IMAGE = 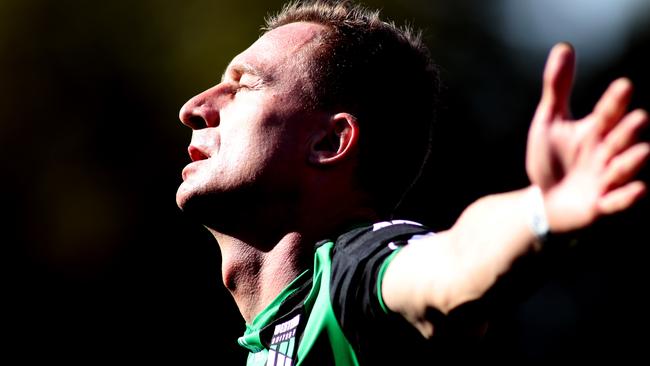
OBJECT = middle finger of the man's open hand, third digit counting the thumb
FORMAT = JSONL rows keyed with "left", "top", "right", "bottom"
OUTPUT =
{"left": 601, "top": 109, "right": 648, "bottom": 163}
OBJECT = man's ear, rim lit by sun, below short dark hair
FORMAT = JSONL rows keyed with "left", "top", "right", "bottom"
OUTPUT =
{"left": 309, "top": 113, "right": 359, "bottom": 165}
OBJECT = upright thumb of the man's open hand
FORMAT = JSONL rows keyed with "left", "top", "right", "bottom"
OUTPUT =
{"left": 539, "top": 43, "right": 575, "bottom": 119}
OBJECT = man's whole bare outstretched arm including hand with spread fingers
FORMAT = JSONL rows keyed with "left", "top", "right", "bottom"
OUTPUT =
{"left": 382, "top": 44, "right": 650, "bottom": 336}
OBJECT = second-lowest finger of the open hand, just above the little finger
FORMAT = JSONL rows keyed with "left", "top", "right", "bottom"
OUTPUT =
{"left": 602, "top": 142, "right": 650, "bottom": 190}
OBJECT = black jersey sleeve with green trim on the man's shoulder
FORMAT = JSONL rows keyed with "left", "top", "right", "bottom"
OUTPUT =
{"left": 330, "top": 224, "right": 430, "bottom": 364}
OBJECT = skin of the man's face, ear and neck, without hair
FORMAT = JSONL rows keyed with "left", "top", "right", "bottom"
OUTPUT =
{"left": 176, "top": 23, "right": 376, "bottom": 321}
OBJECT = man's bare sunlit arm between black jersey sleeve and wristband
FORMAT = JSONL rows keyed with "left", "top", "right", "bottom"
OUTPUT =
{"left": 382, "top": 187, "right": 543, "bottom": 336}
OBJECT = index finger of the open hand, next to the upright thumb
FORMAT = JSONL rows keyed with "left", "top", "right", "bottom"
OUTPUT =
{"left": 592, "top": 78, "right": 632, "bottom": 138}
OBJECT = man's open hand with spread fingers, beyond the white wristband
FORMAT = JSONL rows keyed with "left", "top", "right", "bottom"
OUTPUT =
{"left": 526, "top": 45, "right": 650, "bottom": 231}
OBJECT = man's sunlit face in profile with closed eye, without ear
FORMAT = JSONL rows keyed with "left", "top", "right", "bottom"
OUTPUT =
{"left": 176, "top": 23, "right": 324, "bottom": 216}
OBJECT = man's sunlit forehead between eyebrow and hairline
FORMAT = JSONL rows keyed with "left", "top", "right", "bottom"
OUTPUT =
{"left": 226, "top": 22, "right": 326, "bottom": 78}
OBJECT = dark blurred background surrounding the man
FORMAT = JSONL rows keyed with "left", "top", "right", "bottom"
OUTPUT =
{"left": 0, "top": 0, "right": 650, "bottom": 364}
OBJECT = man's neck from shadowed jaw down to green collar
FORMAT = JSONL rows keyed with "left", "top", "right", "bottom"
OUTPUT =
{"left": 208, "top": 195, "right": 377, "bottom": 324}
